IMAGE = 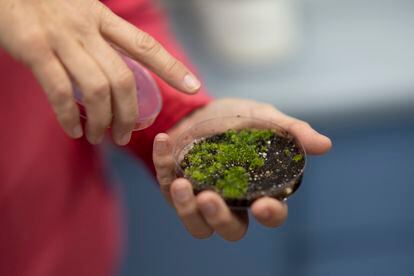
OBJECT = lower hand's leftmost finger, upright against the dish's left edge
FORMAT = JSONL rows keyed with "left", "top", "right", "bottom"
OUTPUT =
{"left": 152, "top": 133, "right": 176, "bottom": 202}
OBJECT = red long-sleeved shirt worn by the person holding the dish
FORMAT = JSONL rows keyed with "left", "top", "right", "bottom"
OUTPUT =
{"left": 0, "top": 0, "right": 209, "bottom": 276}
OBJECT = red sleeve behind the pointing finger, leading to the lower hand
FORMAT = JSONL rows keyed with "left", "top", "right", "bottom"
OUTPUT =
{"left": 106, "top": 0, "right": 211, "bottom": 171}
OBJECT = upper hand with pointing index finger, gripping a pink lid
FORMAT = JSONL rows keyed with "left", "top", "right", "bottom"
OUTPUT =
{"left": 0, "top": 0, "right": 200, "bottom": 145}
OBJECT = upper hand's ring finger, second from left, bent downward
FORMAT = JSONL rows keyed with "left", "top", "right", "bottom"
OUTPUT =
{"left": 56, "top": 39, "right": 112, "bottom": 144}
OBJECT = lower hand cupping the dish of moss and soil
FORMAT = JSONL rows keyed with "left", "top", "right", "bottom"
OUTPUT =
{"left": 153, "top": 99, "right": 331, "bottom": 241}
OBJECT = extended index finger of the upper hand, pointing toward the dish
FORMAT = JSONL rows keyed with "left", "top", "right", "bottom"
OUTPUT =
{"left": 100, "top": 11, "right": 201, "bottom": 93}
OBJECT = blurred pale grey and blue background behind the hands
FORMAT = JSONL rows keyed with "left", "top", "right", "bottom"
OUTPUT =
{"left": 110, "top": 0, "right": 414, "bottom": 276}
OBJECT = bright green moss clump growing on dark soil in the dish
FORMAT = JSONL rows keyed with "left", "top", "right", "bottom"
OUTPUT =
{"left": 183, "top": 129, "right": 275, "bottom": 198}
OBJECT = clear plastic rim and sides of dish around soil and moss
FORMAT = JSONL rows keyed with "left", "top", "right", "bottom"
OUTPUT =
{"left": 173, "top": 116, "right": 306, "bottom": 209}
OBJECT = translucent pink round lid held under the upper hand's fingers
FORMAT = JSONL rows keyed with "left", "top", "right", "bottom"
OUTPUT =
{"left": 74, "top": 55, "right": 162, "bottom": 131}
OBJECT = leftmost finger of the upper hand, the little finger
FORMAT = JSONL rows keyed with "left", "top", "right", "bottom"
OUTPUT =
{"left": 32, "top": 52, "right": 83, "bottom": 138}
